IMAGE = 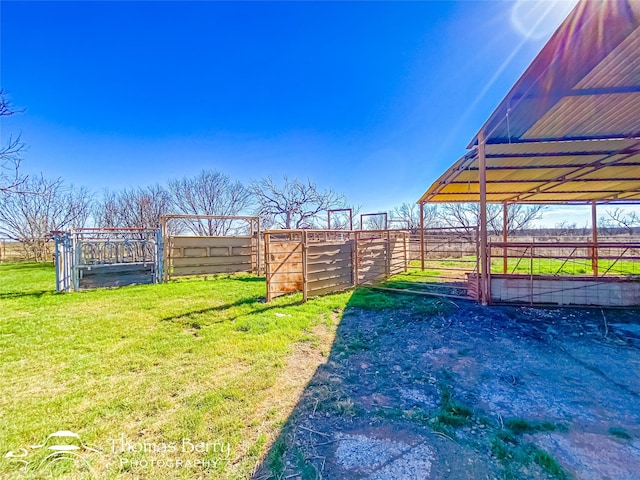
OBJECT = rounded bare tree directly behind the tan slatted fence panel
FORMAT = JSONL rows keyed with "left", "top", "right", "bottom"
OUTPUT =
{"left": 169, "top": 170, "right": 251, "bottom": 236}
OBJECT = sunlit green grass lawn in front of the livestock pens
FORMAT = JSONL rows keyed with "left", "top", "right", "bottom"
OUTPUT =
{"left": 0, "top": 263, "right": 436, "bottom": 479}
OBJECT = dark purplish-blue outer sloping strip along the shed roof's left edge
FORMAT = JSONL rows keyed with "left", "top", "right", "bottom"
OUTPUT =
{"left": 467, "top": 0, "right": 640, "bottom": 148}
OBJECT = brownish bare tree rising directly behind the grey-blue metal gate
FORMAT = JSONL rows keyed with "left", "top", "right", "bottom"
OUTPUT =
{"left": 94, "top": 184, "right": 171, "bottom": 229}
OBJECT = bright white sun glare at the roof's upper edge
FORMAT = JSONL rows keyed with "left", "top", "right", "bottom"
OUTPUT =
{"left": 511, "top": 0, "right": 578, "bottom": 40}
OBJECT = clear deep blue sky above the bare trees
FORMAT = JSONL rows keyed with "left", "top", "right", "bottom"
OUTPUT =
{"left": 0, "top": 0, "right": 600, "bottom": 225}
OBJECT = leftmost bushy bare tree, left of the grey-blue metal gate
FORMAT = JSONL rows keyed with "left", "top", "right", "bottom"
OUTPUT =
{"left": 0, "top": 176, "right": 93, "bottom": 260}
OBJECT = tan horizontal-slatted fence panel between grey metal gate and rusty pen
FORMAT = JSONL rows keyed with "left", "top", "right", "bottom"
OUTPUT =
{"left": 169, "top": 236, "right": 256, "bottom": 277}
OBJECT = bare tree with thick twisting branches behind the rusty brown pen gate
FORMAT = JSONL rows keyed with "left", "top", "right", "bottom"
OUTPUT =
{"left": 250, "top": 176, "right": 347, "bottom": 229}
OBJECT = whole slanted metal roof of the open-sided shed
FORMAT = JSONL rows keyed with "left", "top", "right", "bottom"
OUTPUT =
{"left": 419, "top": 0, "right": 640, "bottom": 203}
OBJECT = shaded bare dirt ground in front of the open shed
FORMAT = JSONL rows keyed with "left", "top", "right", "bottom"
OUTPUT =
{"left": 254, "top": 298, "right": 640, "bottom": 480}
